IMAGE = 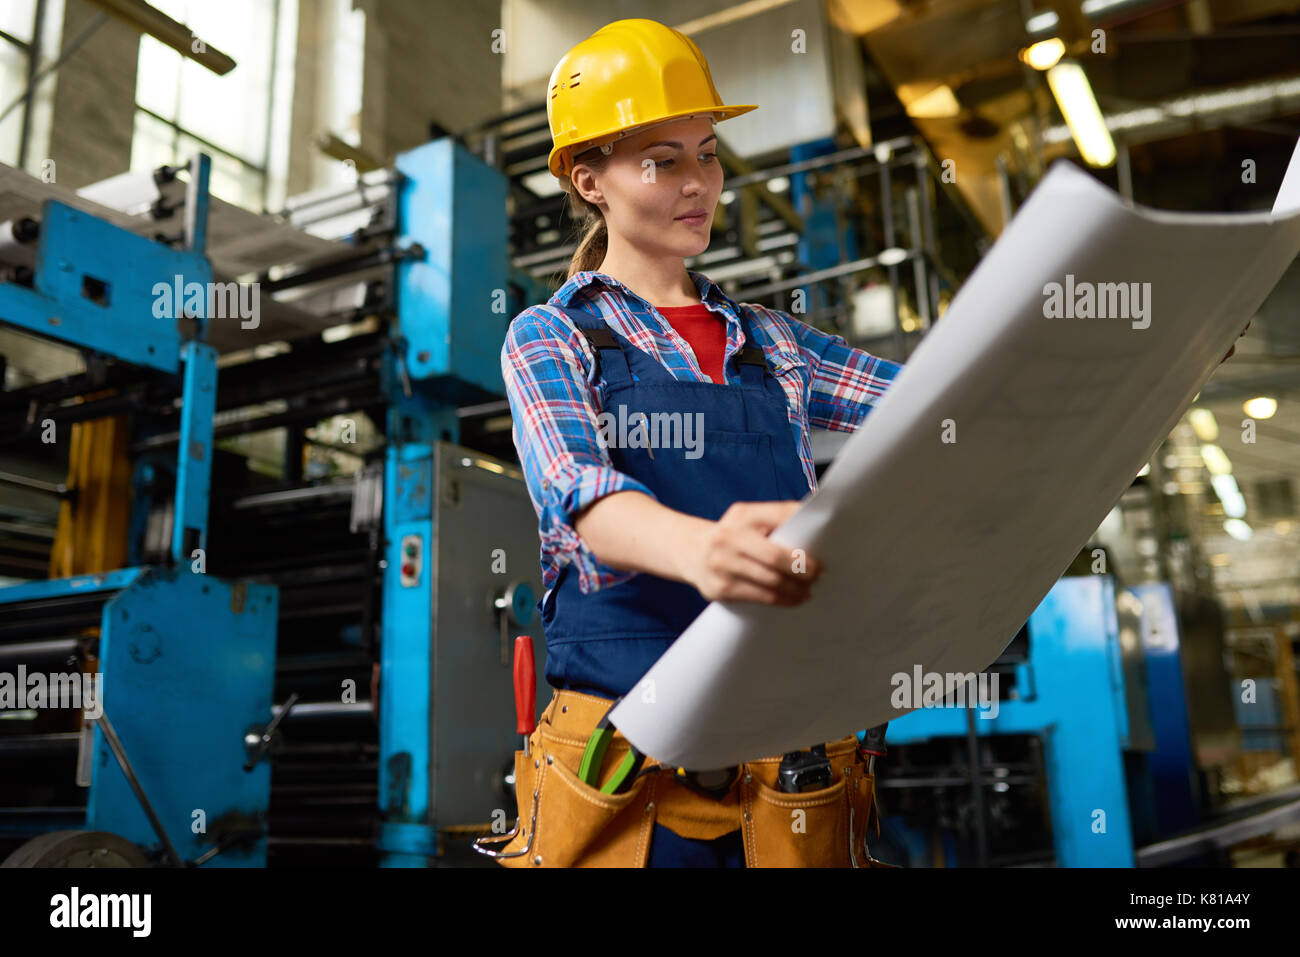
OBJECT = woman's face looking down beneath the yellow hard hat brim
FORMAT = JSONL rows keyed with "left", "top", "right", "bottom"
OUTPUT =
{"left": 573, "top": 116, "right": 723, "bottom": 259}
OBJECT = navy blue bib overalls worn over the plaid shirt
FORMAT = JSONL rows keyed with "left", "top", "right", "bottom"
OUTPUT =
{"left": 540, "top": 309, "right": 810, "bottom": 867}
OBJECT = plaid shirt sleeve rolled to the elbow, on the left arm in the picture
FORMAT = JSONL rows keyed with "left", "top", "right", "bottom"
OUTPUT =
{"left": 501, "top": 306, "right": 655, "bottom": 593}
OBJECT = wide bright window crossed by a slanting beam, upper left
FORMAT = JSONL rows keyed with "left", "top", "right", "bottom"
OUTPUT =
{"left": 131, "top": 0, "right": 284, "bottom": 209}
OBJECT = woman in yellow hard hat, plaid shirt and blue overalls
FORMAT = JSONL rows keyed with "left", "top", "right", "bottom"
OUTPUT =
{"left": 486, "top": 20, "right": 901, "bottom": 867}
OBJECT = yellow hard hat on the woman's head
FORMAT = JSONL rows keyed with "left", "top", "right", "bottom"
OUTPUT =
{"left": 546, "top": 20, "right": 758, "bottom": 177}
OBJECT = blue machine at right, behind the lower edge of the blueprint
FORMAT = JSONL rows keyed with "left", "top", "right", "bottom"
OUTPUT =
{"left": 881, "top": 575, "right": 1227, "bottom": 867}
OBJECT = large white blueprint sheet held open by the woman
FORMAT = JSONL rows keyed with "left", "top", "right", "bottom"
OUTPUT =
{"left": 610, "top": 143, "right": 1300, "bottom": 768}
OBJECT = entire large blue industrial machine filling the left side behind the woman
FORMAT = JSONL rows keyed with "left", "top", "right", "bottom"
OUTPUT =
{"left": 0, "top": 138, "right": 546, "bottom": 866}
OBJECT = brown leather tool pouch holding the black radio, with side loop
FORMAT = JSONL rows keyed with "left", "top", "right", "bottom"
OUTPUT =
{"left": 740, "top": 739, "right": 874, "bottom": 867}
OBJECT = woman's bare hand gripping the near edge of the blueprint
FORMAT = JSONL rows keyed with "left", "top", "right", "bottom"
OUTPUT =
{"left": 684, "top": 502, "right": 822, "bottom": 605}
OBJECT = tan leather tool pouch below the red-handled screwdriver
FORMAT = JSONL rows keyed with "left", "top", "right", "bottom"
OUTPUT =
{"left": 499, "top": 723, "right": 654, "bottom": 867}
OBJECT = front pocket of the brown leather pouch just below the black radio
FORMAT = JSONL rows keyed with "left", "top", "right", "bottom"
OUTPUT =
{"left": 741, "top": 775, "right": 861, "bottom": 867}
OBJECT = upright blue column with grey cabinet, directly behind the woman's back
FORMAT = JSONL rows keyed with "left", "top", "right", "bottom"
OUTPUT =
{"left": 276, "top": 138, "right": 546, "bottom": 866}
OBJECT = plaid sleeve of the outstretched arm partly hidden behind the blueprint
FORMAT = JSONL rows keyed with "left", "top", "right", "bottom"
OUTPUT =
{"left": 787, "top": 313, "right": 902, "bottom": 432}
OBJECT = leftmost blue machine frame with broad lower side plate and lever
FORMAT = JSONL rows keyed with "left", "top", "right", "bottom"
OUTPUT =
{"left": 0, "top": 156, "right": 277, "bottom": 866}
